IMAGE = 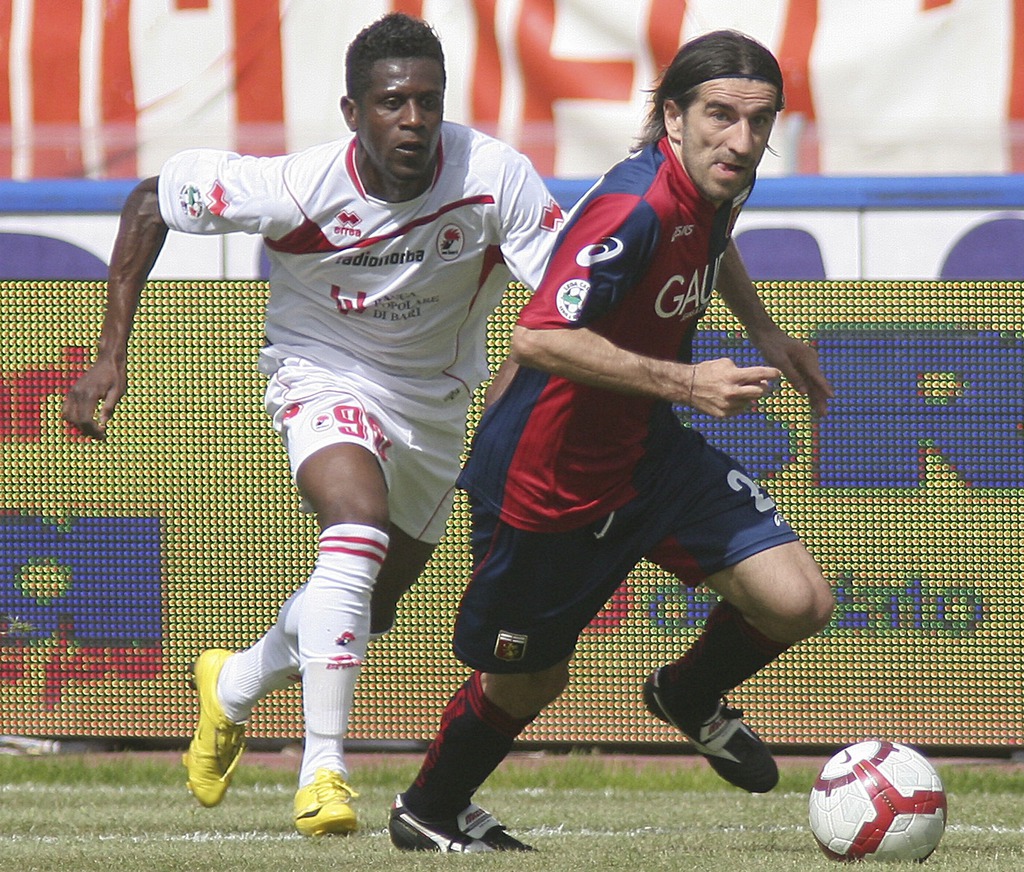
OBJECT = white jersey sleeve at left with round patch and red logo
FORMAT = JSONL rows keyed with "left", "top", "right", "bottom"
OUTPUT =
{"left": 158, "top": 148, "right": 303, "bottom": 238}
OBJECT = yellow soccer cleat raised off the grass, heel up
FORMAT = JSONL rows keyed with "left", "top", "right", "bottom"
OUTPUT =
{"left": 181, "top": 648, "right": 246, "bottom": 809}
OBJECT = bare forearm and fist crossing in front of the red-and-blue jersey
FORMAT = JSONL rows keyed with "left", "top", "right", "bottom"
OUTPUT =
{"left": 511, "top": 324, "right": 782, "bottom": 418}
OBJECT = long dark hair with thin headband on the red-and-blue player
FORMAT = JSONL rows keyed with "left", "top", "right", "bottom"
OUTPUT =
{"left": 637, "top": 31, "right": 785, "bottom": 148}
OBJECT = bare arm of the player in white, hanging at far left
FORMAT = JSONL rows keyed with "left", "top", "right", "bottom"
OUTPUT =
{"left": 62, "top": 177, "right": 168, "bottom": 439}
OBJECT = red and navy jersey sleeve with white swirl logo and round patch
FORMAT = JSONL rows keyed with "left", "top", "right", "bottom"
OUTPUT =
{"left": 519, "top": 192, "right": 662, "bottom": 330}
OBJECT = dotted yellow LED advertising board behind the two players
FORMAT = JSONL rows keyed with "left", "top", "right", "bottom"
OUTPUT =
{"left": 0, "top": 281, "right": 1024, "bottom": 745}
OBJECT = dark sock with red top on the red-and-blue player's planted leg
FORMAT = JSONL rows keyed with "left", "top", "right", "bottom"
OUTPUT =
{"left": 402, "top": 672, "right": 534, "bottom": 821}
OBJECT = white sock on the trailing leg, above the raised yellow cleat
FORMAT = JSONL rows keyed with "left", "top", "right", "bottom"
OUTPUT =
{"left": 217, "top": 584, "right": 305, "bottom": 724}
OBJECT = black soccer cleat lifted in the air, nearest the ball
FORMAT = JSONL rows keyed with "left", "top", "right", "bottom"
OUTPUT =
{"left": 643, "top": 669, "right": 778, "bottom": 793}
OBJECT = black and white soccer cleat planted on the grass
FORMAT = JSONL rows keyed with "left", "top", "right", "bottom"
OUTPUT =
{"left": 388, "top": 793, "right": 534, "bottom": 854}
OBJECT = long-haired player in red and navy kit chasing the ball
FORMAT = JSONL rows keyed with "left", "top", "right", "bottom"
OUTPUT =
{"left": 390, "top": 31, "right": 834, "bottom": 852}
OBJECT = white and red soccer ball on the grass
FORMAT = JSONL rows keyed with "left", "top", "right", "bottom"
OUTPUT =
{"left": 810, "top": 740, "right": 946, "bottom": 861}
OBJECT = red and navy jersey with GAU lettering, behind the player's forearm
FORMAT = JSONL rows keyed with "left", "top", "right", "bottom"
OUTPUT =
{"left": 460, "top": 139, "right": 750, "bottom": 531}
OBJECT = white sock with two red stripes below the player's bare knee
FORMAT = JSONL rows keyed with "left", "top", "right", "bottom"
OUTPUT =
{"left": 298, "top": 524, "right": 388, "bottom": 787}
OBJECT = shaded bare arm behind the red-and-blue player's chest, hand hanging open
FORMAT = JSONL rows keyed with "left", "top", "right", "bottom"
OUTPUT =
{"left": 718, "top": 239, "right": 835, "bottom": 415}
